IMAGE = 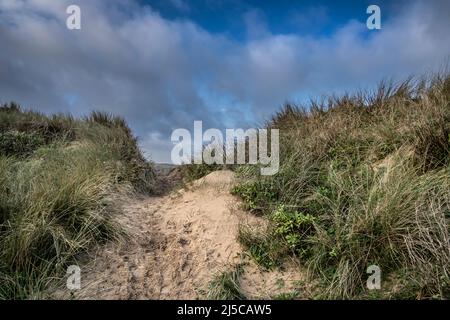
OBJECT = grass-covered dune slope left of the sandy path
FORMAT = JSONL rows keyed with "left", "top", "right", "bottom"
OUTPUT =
{"left": 0, "top": 103, "right": 154, "bottom": 299}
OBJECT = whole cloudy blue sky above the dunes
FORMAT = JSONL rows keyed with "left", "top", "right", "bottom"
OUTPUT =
{"left": 0, "top": 0, "right": 450, "bottom": 162}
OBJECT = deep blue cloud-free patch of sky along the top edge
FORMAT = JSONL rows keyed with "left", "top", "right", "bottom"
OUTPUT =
{"left": 140, "top": 0, "right": 392, "bottom": 41}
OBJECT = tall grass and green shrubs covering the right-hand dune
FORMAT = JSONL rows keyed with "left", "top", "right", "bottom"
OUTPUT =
{"left": 232, "top": 75, "right": 450, "bottom": 299}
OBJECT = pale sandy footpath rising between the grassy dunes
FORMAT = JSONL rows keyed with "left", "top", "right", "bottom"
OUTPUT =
{"left": 54, "top": 171, "right": 304, "bottom": 299}
